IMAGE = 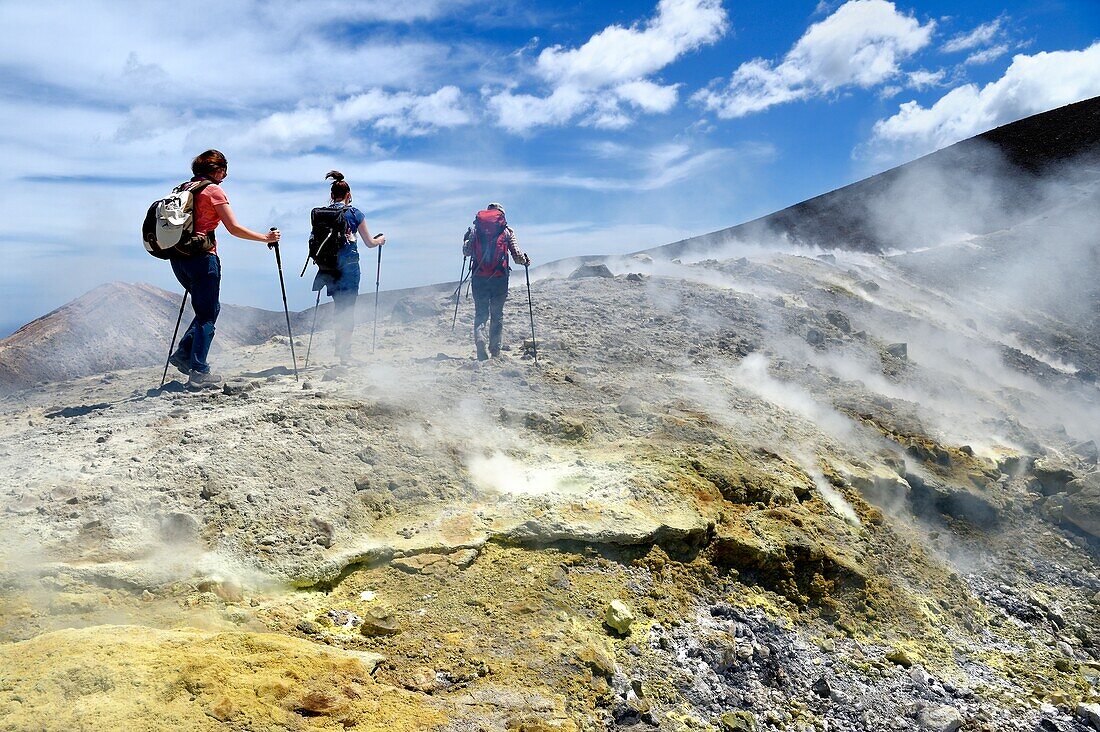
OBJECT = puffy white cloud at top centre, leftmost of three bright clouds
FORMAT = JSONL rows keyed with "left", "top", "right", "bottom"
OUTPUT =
{"left": 484, "top": 0, "right": 727, "bottom": 132}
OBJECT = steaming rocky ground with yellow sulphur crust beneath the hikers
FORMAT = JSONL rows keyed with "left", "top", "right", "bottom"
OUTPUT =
{"left": 0, "top": 226, "right": 1100, "bottom": 732}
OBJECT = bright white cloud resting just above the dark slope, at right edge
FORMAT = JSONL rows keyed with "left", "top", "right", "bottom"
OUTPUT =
{"left": 857, "top": 42, "right": 1100, "bottom": 161}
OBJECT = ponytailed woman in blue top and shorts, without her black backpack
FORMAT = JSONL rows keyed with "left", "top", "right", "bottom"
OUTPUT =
{"left": 312, "top": 171, "right": 386, "bottom": 363}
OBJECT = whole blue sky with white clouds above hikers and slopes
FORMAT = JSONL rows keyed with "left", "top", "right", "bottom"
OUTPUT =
{"left": 0, "top": 0, "right": 1100, "bottom": 336}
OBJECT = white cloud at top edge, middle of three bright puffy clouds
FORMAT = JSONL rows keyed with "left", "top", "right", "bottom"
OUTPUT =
{"left": 694, "top": 0, "right": 935, "bottom": 119}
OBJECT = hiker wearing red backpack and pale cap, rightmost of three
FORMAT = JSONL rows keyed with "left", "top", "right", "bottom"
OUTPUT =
{"left": 462, "top": 204, "right": 531, "bottom": 361}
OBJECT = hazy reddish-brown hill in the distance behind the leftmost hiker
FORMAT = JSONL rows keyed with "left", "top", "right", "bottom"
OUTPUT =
{"left": 0, "top": 282, "right": 286, "bottom": 391}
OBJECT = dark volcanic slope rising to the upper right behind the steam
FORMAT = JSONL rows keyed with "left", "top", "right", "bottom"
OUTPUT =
{"left": 649, "top": 97, "right": 1100, "bottom": 258}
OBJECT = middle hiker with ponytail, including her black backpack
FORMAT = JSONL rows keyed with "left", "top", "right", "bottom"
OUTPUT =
{"left": 309, "top": 171, "right": 386, "bottom": 364}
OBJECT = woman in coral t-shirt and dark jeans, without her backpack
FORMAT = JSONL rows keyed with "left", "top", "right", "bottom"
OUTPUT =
{"left": 168, "top": 150, "right": 281, "bottom": 386}
